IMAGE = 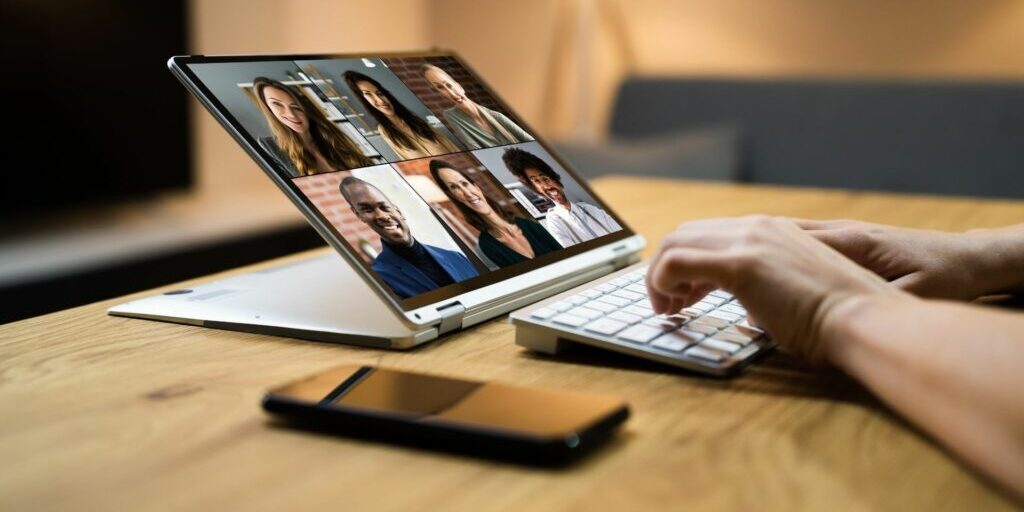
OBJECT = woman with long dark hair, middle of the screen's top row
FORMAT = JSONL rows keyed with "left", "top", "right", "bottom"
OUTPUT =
{"left": 342, "top": 71, "right": 459, "bottom": 160}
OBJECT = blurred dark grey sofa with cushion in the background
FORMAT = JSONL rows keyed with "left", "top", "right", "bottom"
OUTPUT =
{"left": 560, "top": 78, "right": 1024, "bottom": 198}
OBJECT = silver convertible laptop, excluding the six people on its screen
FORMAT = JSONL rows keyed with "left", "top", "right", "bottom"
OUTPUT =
{"left": 109, "top": 51, "right": 645, "bottom": 348}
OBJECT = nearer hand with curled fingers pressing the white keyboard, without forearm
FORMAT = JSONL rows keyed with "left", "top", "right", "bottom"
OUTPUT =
{"left": 646, "top": 216, "right": 908, "bottom": 364}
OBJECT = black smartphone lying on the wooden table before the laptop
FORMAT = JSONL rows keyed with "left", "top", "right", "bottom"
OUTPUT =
{"left": 263, "top": 367, "right": 630, "bottom": 465}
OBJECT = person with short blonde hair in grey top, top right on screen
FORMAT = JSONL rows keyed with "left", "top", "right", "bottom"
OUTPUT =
{"left": 420, "top": 65, "right": 534, "bottom": 150}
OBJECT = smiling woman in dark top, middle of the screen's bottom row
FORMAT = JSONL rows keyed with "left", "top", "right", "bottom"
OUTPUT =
{"left": 430, "top": 160, "right": 562, "bottom": 267}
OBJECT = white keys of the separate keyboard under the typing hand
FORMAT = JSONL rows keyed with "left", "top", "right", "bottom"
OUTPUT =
{"left": 520, "top": 267, "right": 770, "bottom": 373}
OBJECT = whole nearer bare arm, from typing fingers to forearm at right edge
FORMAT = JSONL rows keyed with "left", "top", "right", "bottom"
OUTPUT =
{"left": 647, "top": 217, "right": 1024, "bottom": 497}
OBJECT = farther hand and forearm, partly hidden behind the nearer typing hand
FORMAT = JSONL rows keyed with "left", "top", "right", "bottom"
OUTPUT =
{"left": 795, "top": 219, "right": 1024, "bottom": 300}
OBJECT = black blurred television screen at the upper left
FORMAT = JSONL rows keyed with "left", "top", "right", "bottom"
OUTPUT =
{"left": 0, "top": 0, "right": 191, "bottom": 217}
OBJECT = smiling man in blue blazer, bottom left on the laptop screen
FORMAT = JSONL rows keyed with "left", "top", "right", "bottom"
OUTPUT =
{"left": 338, "top": 176, "right": 477, "bottom": 299}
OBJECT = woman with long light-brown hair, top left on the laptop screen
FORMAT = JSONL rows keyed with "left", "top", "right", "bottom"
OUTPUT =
{"left": 253, "top": 77, "right": 376, "bottom": 177}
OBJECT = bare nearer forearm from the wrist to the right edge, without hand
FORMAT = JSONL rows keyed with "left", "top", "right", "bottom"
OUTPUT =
{"left": 822, "top": 297, "right": 1024, "bottom": 497}
